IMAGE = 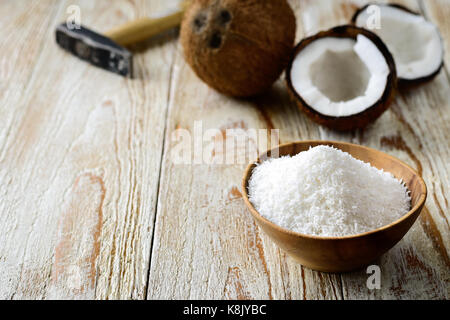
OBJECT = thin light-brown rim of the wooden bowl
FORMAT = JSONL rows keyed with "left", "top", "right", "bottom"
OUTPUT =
{"left": 242, "top": 140, "right": 427, "bottom": 240}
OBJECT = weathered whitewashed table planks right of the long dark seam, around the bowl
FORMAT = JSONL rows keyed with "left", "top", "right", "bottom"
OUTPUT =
{"left": 149, "top": 1, "right": 449, "bottom": 299}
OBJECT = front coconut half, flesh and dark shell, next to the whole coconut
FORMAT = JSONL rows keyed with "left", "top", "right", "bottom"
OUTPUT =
{"left": 286, "top": 26, "right": 397, "bottom": 130}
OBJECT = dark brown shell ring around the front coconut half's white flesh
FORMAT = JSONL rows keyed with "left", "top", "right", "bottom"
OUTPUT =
{"left": 286, "top": 25, "right": 397, "bottom": 131}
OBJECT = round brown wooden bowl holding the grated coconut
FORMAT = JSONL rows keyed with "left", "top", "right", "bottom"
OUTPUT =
{"left": 242, "top": 140, "right": 427, "bottom": 272}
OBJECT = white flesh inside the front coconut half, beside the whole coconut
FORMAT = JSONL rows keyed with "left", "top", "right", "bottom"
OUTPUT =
{"left": 290, "top": 35, "right": 390, "bottom": 117}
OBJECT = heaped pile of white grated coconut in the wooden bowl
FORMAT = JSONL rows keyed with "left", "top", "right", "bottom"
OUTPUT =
{"left": 248, "top": 146, "right": 411, "bottom": 237}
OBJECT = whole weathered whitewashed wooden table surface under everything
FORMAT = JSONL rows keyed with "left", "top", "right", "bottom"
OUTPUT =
{"left": 0, "top": 0, "right": 450, "bottom": 299}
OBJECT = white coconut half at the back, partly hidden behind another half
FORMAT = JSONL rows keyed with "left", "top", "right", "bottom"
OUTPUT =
{"left": 352, "top": 4, "right": 444, "bottom": 83}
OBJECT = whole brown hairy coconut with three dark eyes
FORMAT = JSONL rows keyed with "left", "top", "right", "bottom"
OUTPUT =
{"left": 180, "top": 0, "right": 295, "bottom": 97}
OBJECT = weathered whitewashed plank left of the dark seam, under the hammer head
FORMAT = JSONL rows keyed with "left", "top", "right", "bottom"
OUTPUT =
{"left": 0, "top": 1, "right": 176, "bottom": 299}
